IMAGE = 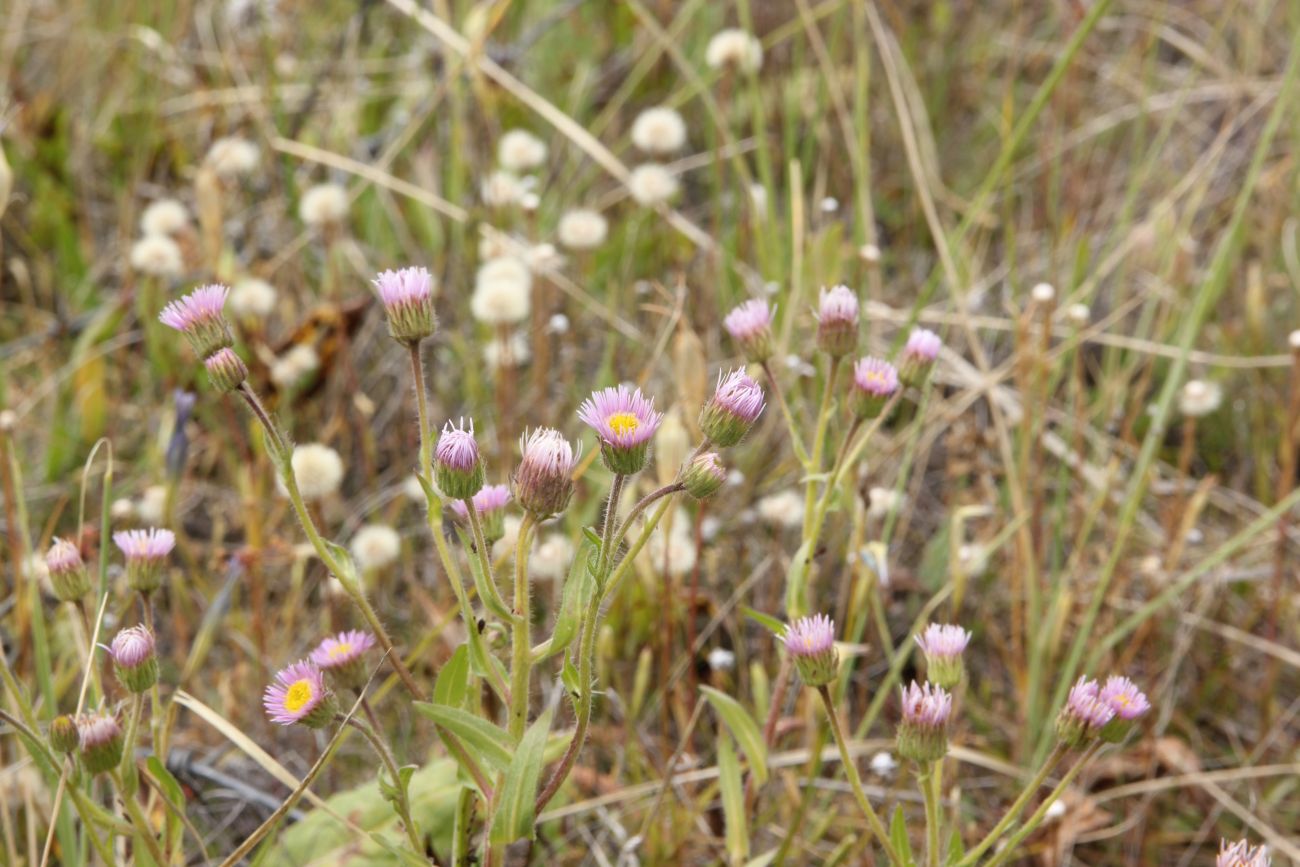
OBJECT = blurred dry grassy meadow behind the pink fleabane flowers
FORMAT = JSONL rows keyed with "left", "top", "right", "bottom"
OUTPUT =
{"left": 0, "top": 0, "right": 1300, "bottom": 866}
